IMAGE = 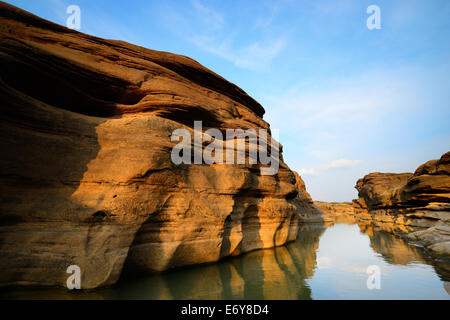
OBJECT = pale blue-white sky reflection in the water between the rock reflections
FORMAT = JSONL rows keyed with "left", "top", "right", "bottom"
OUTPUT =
{"left": 306, "top": 224, "right": 450, "bottom": 299}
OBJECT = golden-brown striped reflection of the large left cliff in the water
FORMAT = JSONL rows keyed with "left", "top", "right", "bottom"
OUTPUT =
{"left": 106, "top": 224, "right": 324, "bottom": 299}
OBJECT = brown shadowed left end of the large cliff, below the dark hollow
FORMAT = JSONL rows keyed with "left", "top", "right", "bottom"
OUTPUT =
{"left": 0, "top": 68, "right": 125, "bottom": 285}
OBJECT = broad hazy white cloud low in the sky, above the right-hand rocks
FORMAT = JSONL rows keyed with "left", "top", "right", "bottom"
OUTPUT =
{"left": 259, "top": 64, "right": 450, "bottom": 201}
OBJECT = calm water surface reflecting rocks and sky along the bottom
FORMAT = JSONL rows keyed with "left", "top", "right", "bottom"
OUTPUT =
{"left": 0, "top": 224, "right": 450, "bottom": 300}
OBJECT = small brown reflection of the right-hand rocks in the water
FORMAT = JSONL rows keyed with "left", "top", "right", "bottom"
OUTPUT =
{"left": 359, "top": 223, "right": 450, "bottom": 281}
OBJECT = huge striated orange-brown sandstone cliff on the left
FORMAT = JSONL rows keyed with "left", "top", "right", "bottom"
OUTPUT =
{"left": 0, "top": 3, "right": 318, "bottom": 288}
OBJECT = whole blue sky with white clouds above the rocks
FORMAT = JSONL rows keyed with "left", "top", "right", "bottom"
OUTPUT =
{"left": 7, "top": 0, "right": 450, "bottom": 201}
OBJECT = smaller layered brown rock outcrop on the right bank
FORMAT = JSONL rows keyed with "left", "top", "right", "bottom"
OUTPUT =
{"left": 355, "top": 152, "right": 450, "bottom": 257}
